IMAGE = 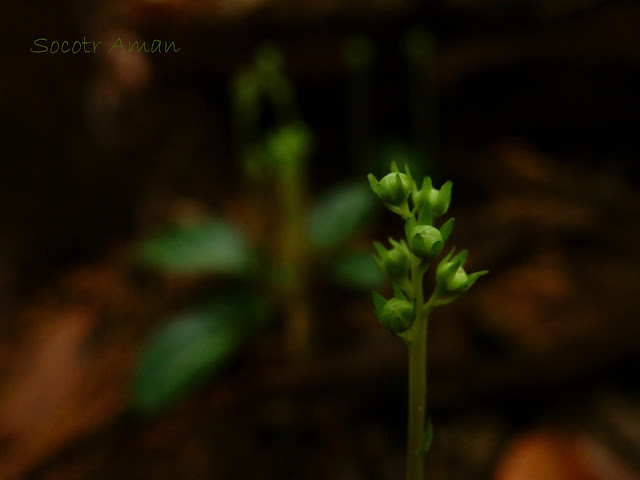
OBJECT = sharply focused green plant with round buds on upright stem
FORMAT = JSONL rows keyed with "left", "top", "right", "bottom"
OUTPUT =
{"left": 368, "top": 163, "right": 488, "bottom": 480}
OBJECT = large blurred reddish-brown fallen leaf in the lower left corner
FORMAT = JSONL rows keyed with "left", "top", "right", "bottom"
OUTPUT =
{"left": 0, "top": 308, "right": 130, "bottom": 480}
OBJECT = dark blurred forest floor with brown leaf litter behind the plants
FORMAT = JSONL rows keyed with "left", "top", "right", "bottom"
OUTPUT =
{"left": 0, "top": 0, "right": 640, "bottom": 480}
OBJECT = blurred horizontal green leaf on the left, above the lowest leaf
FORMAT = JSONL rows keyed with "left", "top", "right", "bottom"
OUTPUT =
{"left": 140, "top": 220, "right": 254, "bottom": 274}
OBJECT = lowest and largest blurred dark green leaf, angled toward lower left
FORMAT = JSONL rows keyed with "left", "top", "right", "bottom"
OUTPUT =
{"left": 132, "top": 291, "right": 269, "bottom": 413}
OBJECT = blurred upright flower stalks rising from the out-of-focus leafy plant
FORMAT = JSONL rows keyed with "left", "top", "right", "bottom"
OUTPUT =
{"left": 232, "top": 43, "right": 311, "bottom": 356}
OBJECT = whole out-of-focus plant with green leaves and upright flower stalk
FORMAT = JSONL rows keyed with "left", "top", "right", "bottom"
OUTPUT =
{"left": 133, "top": 45, "right": 384, "bottom": 412}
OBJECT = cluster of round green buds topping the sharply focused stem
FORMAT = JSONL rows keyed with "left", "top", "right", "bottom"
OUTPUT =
{"left": 368, "top": 162, "right": 487, "bottom": 334}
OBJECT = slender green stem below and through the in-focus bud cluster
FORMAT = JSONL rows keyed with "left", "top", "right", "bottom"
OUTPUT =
{"left": 406, "top": 261, "right": 430, "bottom": 480}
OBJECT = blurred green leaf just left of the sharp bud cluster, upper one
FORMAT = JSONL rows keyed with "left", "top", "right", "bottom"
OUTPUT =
{"left": 309, "top": 183, "right": 376, "bottom": 249}
